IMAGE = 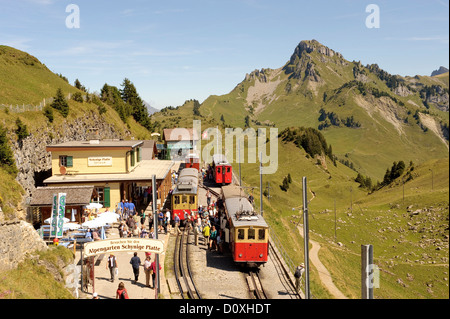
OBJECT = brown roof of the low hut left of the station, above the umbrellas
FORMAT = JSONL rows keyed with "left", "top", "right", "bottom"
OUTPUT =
{"left": 30, "top": 186, "right": 94, "bottom": 207}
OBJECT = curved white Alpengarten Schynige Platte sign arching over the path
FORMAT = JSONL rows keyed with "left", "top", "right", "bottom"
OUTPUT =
{"left": 83, "top": 238, "right": 164, "bottom": 257}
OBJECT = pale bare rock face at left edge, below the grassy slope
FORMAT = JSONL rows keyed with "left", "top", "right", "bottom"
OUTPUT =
{"left": 0, "top": 219, "right": 48, "bottom": 271}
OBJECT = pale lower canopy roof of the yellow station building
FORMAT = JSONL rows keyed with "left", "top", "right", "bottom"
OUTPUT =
{"left": 44, "top": 160, "right": 174, "bottom": 184}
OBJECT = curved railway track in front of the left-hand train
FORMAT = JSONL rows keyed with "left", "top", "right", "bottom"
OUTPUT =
{"left": 173, "top": 229, "right": 202, "bottom": 299}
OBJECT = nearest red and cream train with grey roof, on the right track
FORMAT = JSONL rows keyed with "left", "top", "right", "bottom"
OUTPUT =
{"left": 222, "top": 185, "right": 269, "bottom": 267}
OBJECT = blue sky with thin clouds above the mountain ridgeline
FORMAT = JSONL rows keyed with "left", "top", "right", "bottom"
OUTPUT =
{"left": 0, "top": 0, "right": 449, "bottom": 108}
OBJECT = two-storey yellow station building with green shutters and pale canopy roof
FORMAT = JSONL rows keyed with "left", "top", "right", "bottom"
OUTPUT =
{"left": 44, "top": 140, "right": 174, "bottom": 209}
